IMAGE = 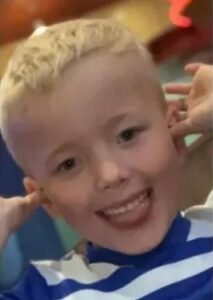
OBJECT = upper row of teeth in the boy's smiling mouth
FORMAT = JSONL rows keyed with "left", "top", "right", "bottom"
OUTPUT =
{"left": 104, "top": 193, "right": 147, "bottom": 216}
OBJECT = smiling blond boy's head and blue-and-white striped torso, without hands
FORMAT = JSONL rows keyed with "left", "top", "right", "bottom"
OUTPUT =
{"left": 0, "top": 20, "right": 213, "bottom": 300}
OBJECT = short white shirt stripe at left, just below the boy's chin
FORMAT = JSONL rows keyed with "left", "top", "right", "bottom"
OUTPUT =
{"left": 34, "top": 254, "right": 119, "bottom": 286}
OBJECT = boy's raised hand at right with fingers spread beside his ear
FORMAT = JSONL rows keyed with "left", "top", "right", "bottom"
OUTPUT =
{"left": 165, "top": 63, "right": 213, "bottom": 137}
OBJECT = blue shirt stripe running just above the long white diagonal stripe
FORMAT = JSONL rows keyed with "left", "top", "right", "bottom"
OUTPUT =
{"left": 2, "top": 238, "right": 210, "bottom": 300}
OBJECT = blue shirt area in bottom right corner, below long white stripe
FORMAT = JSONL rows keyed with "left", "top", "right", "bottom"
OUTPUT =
{"left": 140, "top": 268, "right": 213, "bottom": 300}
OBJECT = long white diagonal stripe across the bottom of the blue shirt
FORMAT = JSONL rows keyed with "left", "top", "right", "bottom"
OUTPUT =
{"left": 59, "top": 252, "right": 213, "bottom": 300}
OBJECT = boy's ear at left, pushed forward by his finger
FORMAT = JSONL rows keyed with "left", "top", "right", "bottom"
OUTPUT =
{"left": 23, "top": 177, "right": 60, "bottom": 219}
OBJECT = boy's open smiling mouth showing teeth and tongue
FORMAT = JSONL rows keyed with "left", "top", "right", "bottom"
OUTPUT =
{"left": 97, "top": 188, "right": 153, "bottom": 229}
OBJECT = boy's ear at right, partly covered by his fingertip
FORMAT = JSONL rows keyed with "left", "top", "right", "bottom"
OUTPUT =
{"left": 166, "top": 103, "right": 187, "bottom": 163}
